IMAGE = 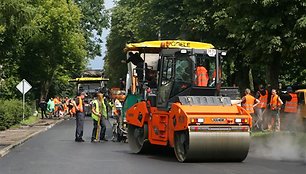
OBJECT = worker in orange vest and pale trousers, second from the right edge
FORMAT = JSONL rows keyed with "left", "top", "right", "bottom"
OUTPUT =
{"left": 268, "top": 89, "right": 283, "bottom": 132}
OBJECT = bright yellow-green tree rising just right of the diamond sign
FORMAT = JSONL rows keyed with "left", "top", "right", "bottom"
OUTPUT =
{"left": 19, "top": 0, "right": 86, "bottom": 97}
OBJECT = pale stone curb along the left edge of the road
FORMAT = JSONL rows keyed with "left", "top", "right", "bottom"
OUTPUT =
{"left": 0, "top": 120, "right": 64, "bottom": 158}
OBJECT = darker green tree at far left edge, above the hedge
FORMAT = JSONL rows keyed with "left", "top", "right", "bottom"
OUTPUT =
{"left": 0, "top": 0, "right": 34, "bottom": 99}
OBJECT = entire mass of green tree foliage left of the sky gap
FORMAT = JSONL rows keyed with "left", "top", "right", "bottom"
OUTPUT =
{"left": 0, "top": 0, "right": 108, "bottom": 98}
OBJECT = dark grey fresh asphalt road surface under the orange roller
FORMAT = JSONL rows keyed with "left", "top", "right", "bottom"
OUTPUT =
{"left": 0, "top": 118, "right": 306, "bottom": 174}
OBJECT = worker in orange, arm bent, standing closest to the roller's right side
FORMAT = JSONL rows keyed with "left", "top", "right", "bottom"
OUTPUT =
{"left": 241, "top": 88, "right": 259, "bottom": 129}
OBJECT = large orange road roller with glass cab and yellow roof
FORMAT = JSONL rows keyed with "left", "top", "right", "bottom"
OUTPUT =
{"left": 125, "top": 41, "right": 252, "bottom": 162}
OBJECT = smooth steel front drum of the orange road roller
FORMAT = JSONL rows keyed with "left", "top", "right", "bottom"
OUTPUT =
{"left": 174, "top": 128, "right": 250, "bottom": 162}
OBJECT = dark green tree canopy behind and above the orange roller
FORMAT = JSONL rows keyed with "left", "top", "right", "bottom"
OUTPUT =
{"left": 105, "top": 0, "right": 306, "bottom": 88}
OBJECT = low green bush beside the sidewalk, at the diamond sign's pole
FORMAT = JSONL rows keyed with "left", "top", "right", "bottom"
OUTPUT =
{"left": 0, "top": 100, "right": 32, "bottom": 130}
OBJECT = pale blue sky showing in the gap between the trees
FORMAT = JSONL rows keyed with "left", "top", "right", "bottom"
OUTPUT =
{"left": 87, "top": 0, "right": 114, "bottom": 69}
